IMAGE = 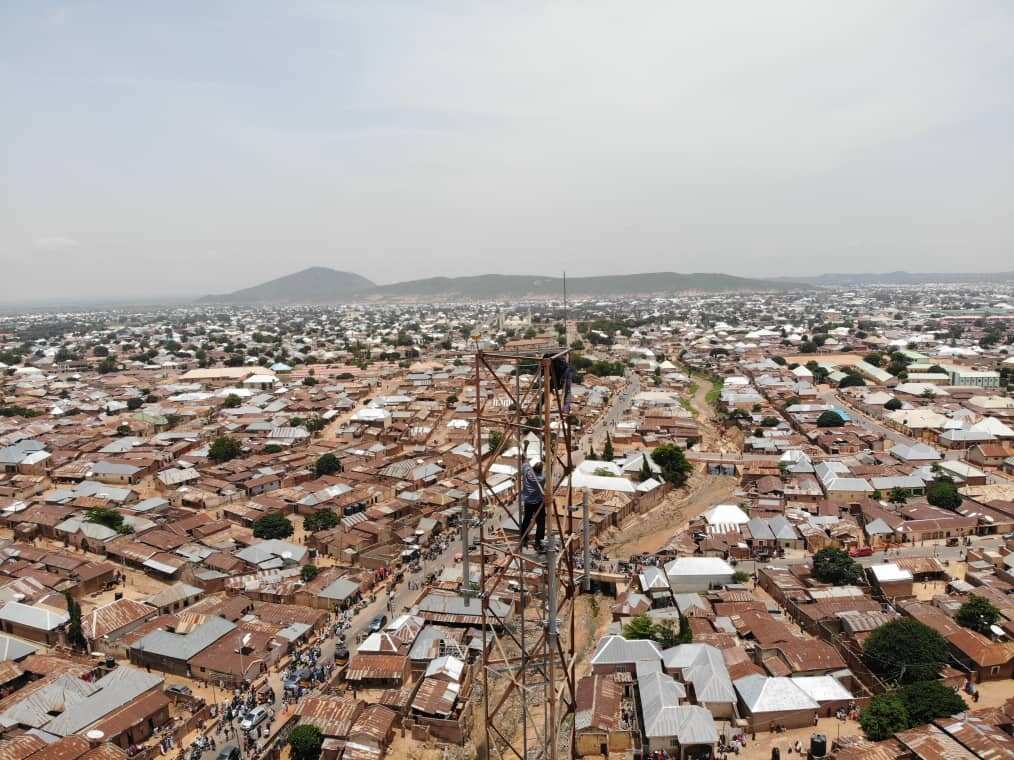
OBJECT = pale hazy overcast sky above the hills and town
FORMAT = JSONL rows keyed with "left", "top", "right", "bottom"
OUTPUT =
{"left": 0, "top": 0, "right": 1014, "bottom": 303}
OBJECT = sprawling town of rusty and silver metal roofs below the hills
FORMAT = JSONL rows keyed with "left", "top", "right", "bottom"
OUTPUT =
{"left": 0, "top": 281, "right": 1014, "bottom": 760}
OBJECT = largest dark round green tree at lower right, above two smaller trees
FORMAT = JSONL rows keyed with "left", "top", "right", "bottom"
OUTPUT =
{"left": 863, "top": 617, "right": 950, "bottom": 684}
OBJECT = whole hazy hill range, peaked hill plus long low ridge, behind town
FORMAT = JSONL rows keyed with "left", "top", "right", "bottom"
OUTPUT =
{"left": 200, "top": 267, "right": 801, "bottom": 304}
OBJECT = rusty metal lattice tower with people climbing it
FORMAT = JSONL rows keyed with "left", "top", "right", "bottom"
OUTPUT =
{"left": 462, "top": 348, "right": 581, "bottom": 760}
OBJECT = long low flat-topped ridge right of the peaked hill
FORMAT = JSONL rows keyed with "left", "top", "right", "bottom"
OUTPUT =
{"left": 360, "top": 272, "right": 799, "bottom": 299}
